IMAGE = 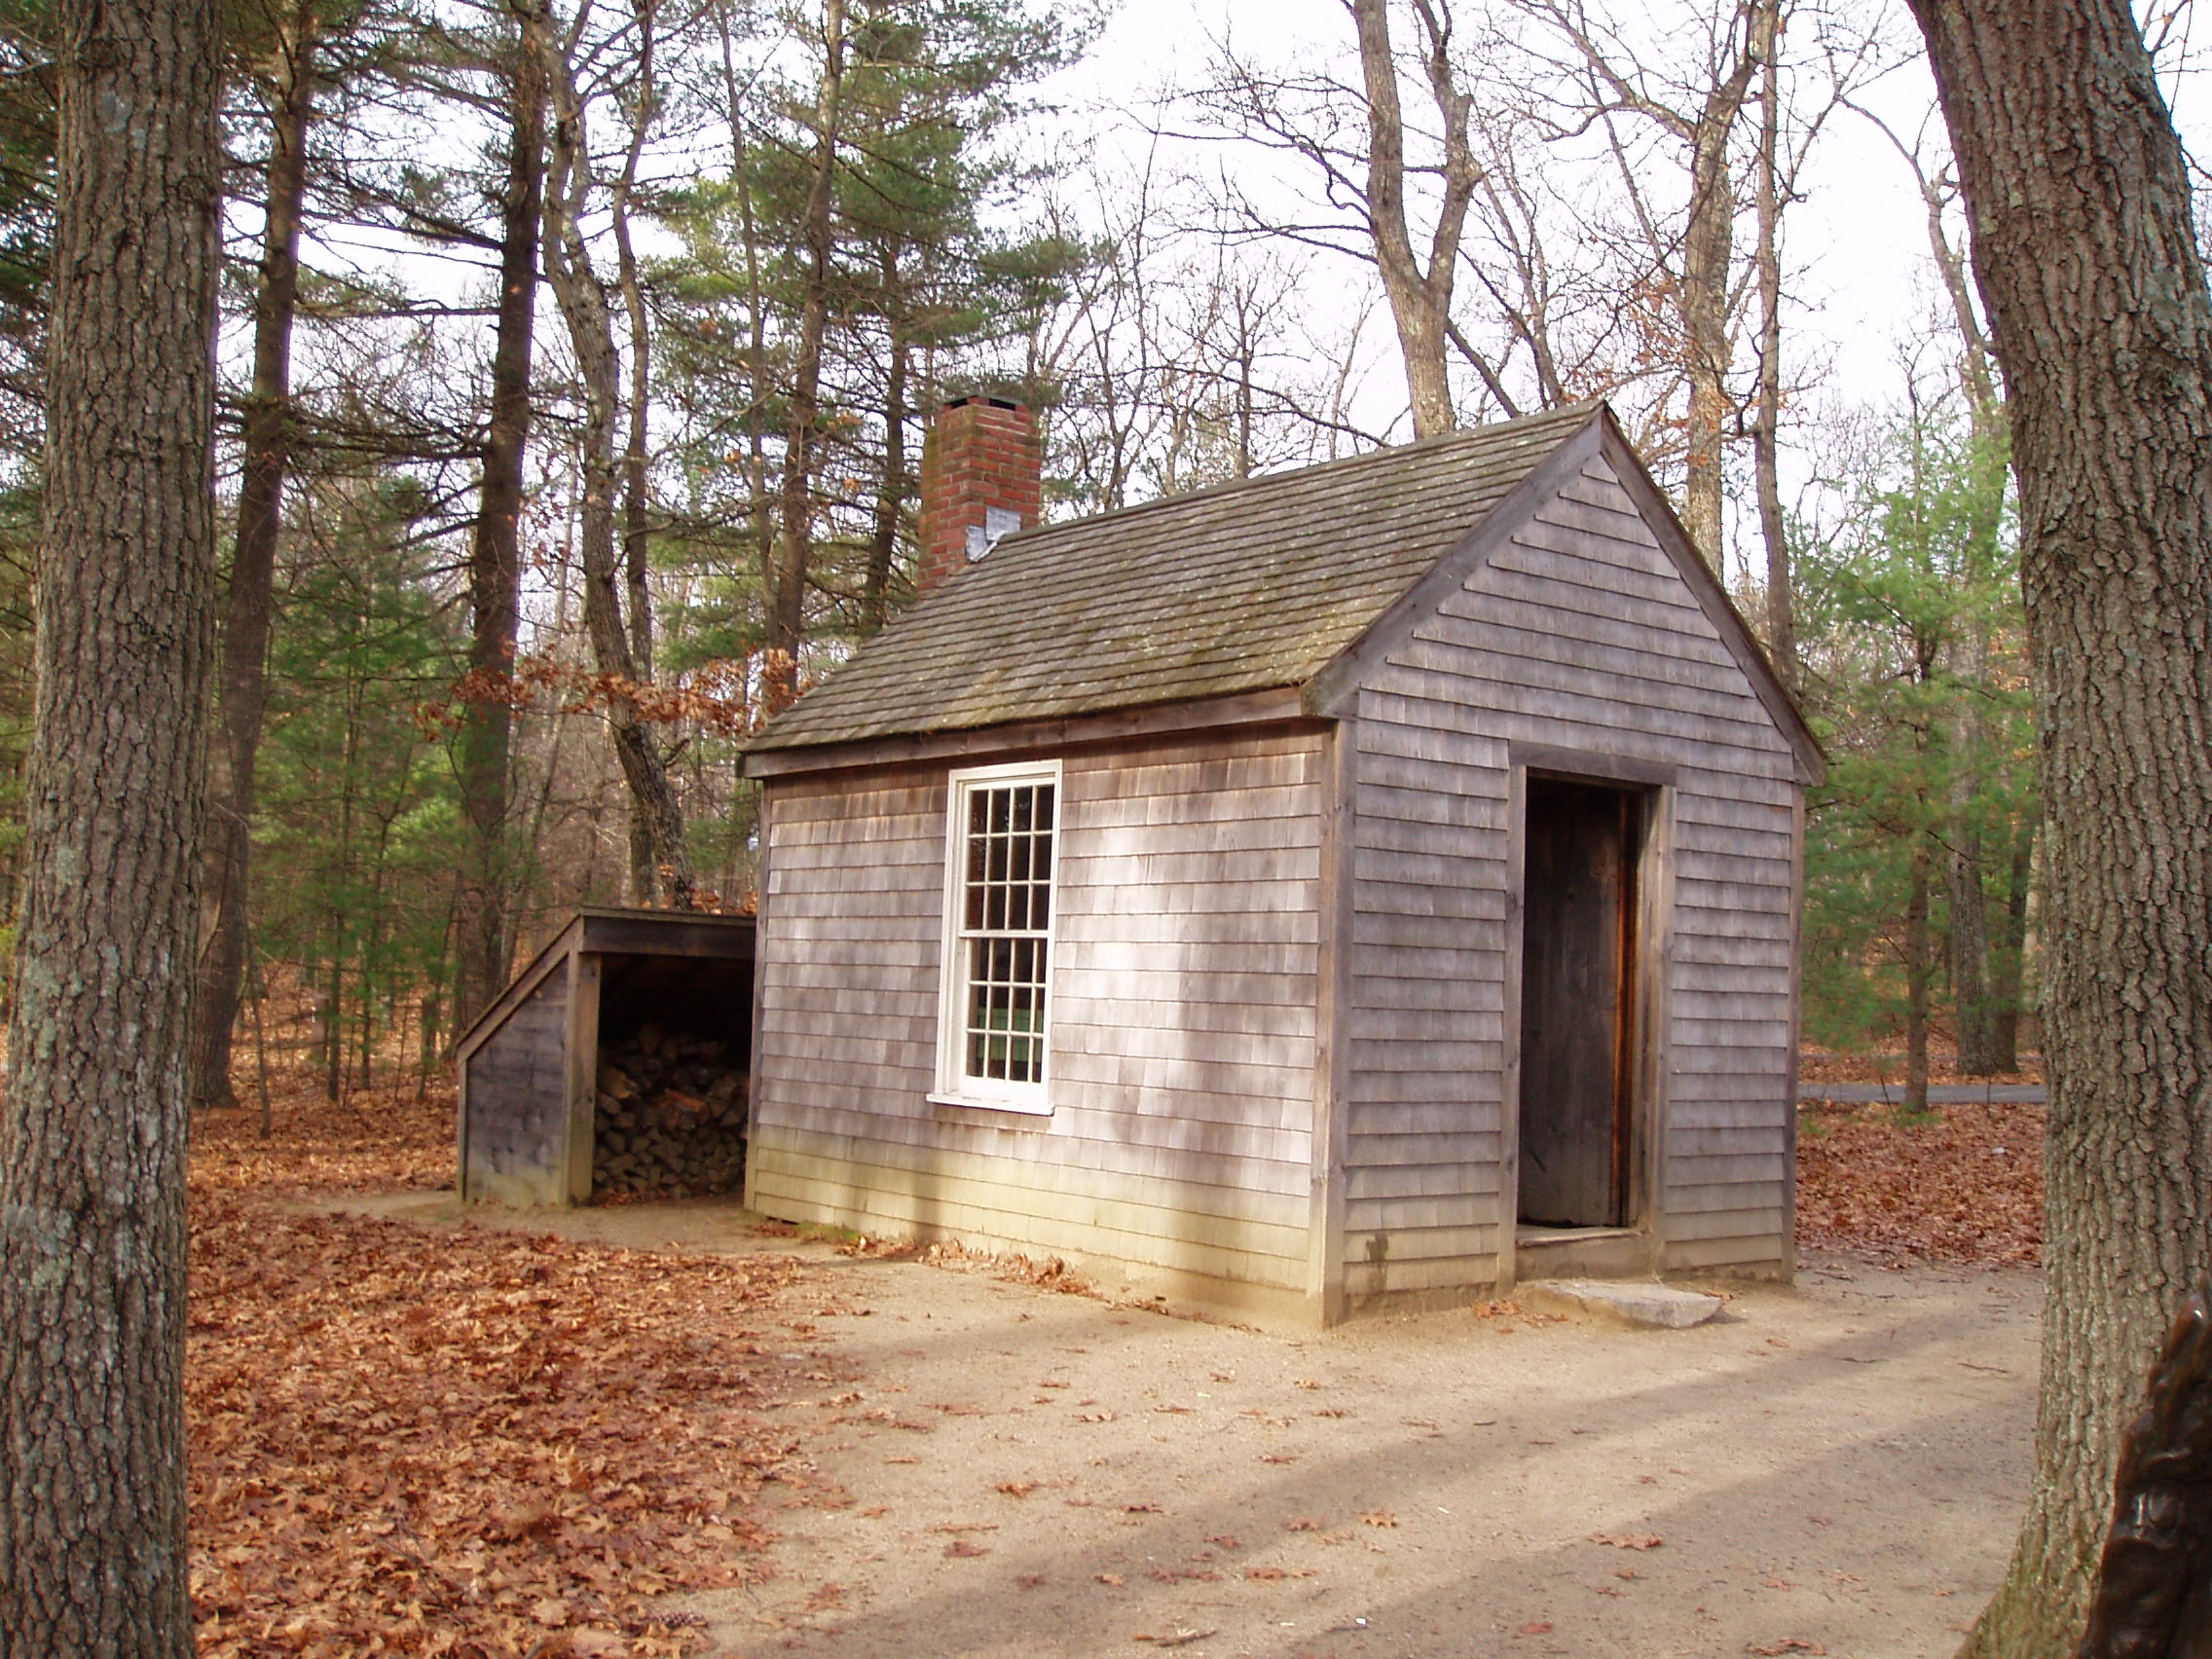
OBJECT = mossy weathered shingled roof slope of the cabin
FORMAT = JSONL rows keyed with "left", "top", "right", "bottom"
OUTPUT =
{"left": 748, "top": 403, "right": 1602, "bottom": 750}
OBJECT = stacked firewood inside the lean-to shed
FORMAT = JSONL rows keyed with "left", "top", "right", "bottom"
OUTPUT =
{"left": 591, "top": 1024, "right": 746, "bottom": 1198}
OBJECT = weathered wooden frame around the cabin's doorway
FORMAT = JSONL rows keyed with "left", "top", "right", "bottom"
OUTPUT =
{"left": 1497, "top": 743, "right": 1678, "bottom": 1290}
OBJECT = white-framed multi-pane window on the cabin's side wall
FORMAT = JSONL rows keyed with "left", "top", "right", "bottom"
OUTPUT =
{"left": 932, "top": 761, "right": 1059, "bottom": 1113}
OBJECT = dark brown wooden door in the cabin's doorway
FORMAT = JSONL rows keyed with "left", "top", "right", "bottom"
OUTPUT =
{"left": 1520, "top": 776, "right": 1641, "bottom": 1228}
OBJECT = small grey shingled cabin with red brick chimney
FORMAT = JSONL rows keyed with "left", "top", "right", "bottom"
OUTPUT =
{"left": 748, "top": 400, "right": 1821, "bottom": 1325}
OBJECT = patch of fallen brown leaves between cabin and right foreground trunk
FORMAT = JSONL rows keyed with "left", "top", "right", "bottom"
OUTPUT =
{"left": 1798, "top": 1104, "right": 2044, "bottom": 1263}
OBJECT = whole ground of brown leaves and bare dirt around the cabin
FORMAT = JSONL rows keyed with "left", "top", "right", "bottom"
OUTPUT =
{"left": 190, "top": 1066, "right": 2042, "bottom": 1659}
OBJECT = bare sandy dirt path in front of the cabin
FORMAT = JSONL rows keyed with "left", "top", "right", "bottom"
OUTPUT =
{"left": 340, "top": 1208, "right": 2038, "bottom": 1659}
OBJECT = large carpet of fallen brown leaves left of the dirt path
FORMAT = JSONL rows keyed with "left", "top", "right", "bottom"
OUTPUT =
{"left": 186, "top": 1101, "right": 803, "bottom": 1659}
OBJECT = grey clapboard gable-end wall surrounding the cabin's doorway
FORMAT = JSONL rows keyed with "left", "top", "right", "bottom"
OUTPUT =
{"left": 1345, "top": 461, "right": 1798, "bottom": 1299}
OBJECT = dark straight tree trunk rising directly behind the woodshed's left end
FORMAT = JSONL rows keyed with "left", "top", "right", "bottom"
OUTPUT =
{"left": 454, "top": 7, "right": 546, "bottom": 1031}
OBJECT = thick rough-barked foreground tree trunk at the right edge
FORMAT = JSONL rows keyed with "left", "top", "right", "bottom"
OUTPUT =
{"left": 1913, "top": 0, "right": 2212, "bottom": 1659}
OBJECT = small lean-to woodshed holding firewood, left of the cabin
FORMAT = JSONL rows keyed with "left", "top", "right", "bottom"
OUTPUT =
{"left": 456, "top": 909, "right": 752, "bottom": 1205}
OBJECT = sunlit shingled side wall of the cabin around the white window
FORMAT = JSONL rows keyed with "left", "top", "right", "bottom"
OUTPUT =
{"left": 752, "top": 730, "right": 1325, "bottom": 1305}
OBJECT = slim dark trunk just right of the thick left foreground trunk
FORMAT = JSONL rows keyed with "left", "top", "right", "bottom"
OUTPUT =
{"left": 188, "top": 0, "right": 320, "bottom": 1106}
